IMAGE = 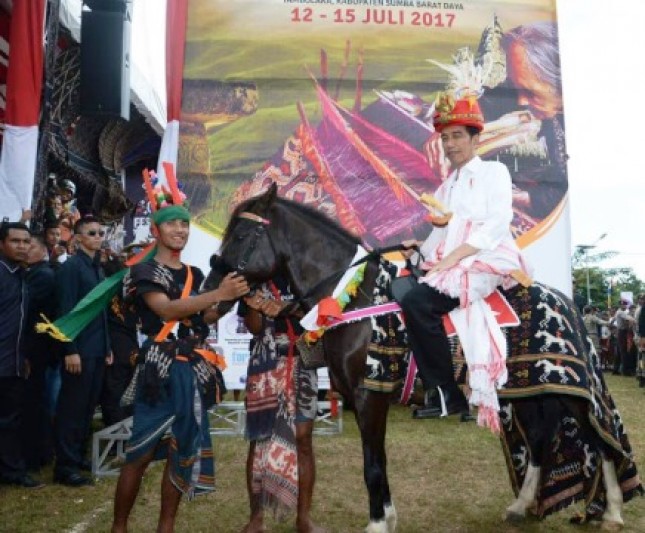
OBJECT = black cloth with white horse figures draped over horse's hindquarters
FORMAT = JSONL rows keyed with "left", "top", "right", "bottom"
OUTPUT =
{"left": 498, "top": 283, "right": 643, "bottom": 518}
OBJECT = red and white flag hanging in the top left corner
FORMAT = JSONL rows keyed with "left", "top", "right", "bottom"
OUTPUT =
{"left": 0, "top": 0, "right": 45, "bottom": 221}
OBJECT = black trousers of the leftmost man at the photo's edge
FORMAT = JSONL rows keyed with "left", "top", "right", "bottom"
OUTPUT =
{"left": 0, "top": 377, "right": 26, "bottom": 479}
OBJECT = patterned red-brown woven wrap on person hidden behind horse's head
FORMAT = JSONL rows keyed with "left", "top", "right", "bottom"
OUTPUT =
{"left": 242, "top": 282, "right": 318, "bottom": 517}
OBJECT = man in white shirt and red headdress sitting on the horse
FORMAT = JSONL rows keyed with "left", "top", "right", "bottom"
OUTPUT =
{"left": 400, "top": 90, "right": 528, "bottom": 425}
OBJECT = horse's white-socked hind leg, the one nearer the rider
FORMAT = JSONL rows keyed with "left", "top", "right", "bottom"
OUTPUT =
{"left": 505, "top": 397, "right": 562, "bottom": 521}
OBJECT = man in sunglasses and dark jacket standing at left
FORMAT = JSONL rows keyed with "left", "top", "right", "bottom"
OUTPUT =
{"left": 54, "top": 216, "right": 111, "bottom": 487}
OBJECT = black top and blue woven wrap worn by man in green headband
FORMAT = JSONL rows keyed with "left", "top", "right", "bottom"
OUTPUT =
{"left": 122, "top": 261, "right": 217, "bottom": 498}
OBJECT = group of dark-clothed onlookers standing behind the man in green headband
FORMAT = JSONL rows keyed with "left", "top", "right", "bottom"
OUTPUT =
{"left": 0, "top": 180, "right": 143, "bottom": 488}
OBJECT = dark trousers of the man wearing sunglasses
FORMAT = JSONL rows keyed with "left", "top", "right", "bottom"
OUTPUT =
{"left": 55, "top": 357, "right": 105, "bottom": 474}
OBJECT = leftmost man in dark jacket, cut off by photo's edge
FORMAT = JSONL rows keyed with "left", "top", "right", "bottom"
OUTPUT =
{"left": 0, "top": 222, "right": 43, "bottom": 488}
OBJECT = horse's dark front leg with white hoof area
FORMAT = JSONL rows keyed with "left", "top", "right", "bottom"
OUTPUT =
{"left": 354, "top": 389, "right": 396, "bottom": 533}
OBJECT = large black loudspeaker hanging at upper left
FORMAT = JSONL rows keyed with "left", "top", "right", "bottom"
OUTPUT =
{"left": 80, "top": 0, "right": 131, "bottom": 120}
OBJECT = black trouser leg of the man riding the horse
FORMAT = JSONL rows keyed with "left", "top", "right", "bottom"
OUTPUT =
{"left": 399, "top": 283, "right": 459, "bottom": 390}
